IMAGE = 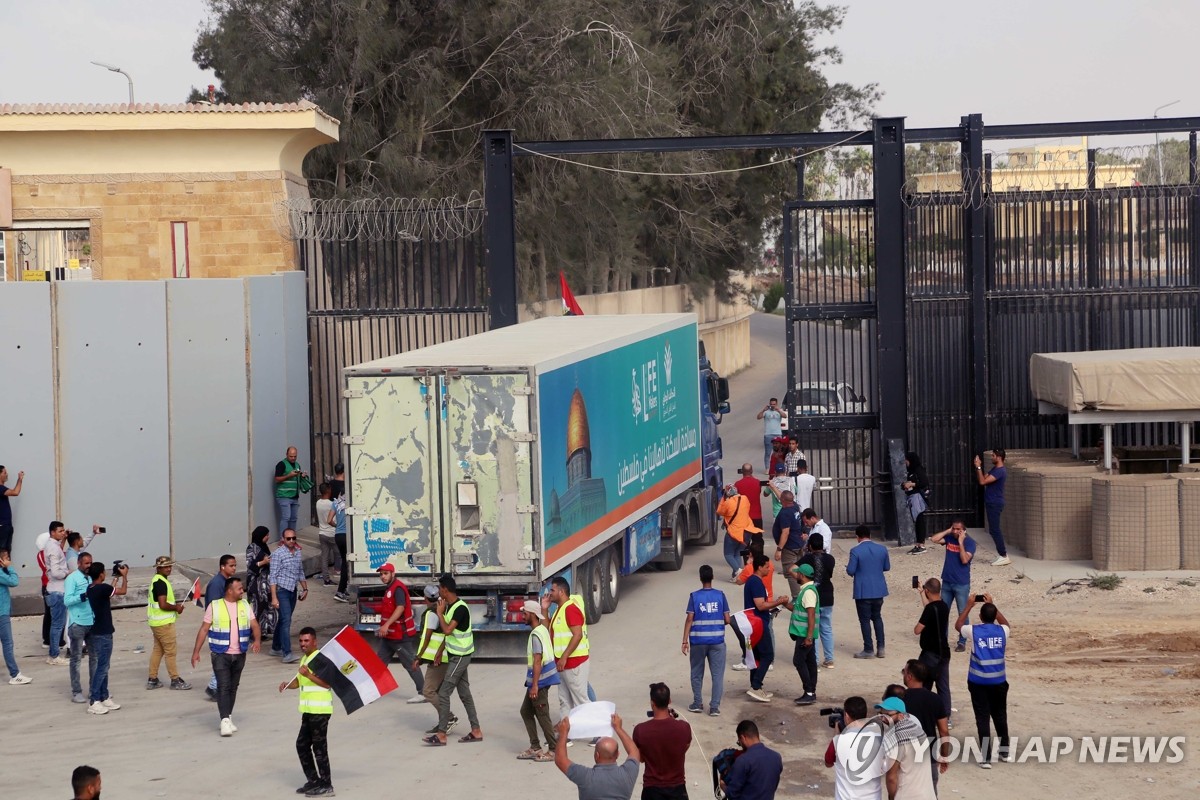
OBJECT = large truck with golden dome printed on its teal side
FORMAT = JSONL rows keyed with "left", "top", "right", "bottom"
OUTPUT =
{"left": 343, "top": 314, "right": 728, "bottom": 656}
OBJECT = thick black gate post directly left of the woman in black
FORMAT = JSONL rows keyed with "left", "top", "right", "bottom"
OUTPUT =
{"left": 874, "top": 116, "right": 913, "bottom": 545}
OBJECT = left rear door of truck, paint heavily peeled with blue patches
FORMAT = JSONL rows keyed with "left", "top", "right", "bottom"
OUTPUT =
{"left": 344, "top": 375, "right": 442, "bottom": 579}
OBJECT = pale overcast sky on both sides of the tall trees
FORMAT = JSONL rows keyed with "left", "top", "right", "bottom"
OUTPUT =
{"left": 0, "top": 0, "right": 1200, "bottom": 146}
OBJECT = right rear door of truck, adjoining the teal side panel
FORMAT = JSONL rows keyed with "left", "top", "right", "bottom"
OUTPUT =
{"left": 439, "top": 373, "right": 536, "bottom": 577}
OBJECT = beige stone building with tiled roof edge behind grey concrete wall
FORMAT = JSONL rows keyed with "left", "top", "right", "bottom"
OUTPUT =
{"left": 0, "top": 102, "right": 338, "bottom": 281}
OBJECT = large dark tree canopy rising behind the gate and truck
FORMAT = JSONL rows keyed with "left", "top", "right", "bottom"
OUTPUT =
{"left": 193, "top": 0, "right": 876, "bottom": 300}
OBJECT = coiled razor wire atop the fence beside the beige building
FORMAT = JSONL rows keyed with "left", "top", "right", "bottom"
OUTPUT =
{"left": 275, "top": 192, "right": 485, "bottom": 241}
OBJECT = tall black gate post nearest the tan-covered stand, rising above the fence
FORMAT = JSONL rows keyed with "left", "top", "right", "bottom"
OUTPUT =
{"left": 962, "top": 114, "right": 988, "bottom": 489}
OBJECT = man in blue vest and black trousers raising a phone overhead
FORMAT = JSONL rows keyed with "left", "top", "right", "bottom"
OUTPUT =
{"left": 954, "top": 594, "right": 1013, "bottom": 769}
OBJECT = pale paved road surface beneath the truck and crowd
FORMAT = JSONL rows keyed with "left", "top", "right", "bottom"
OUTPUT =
{"left": 11, "top": 317, "right": 926, "bottom": 800}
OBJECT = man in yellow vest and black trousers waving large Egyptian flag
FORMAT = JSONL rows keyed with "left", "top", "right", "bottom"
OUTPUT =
{"left": 280, "top": 626, "right": 396, "bottom": 798}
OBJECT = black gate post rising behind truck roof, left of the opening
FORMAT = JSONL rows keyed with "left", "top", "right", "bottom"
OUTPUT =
{"left": 484, "top": 131, "right": 517, "bottom": 329}
